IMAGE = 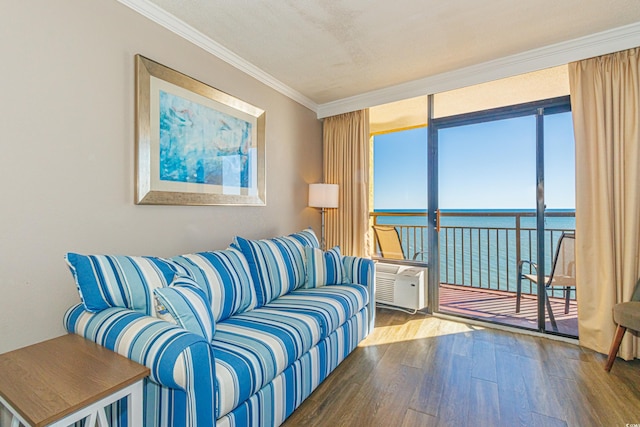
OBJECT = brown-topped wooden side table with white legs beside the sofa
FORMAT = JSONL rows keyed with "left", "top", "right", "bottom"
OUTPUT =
{"left": 0, "top": 334, "right": 149, "bottom": 427}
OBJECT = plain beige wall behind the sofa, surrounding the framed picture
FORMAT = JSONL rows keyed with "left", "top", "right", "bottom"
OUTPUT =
{"left": 0, "top": 0, "right": 322, "bottom": 353}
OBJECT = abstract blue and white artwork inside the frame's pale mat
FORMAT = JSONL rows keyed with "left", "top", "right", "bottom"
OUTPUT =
{"left": 159, "top": 90, "right": 253, "bottom": 188}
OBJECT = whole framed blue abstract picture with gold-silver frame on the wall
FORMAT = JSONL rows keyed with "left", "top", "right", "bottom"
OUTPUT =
{"left": 135, "top": 55, "right": 266, "bottom": 206}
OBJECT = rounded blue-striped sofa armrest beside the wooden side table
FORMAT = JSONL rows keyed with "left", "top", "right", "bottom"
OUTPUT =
{"left": 64, "top": 304, "right": 216, "bottom": 425}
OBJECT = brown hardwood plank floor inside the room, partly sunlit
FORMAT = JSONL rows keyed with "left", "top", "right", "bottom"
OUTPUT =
{"left": 283, "top": 309, "right": 640, "bottom": 427}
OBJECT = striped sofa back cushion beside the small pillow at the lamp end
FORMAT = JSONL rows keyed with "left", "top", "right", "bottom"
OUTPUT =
{"left": 232, "top": 231, "right": 313, "bottom": 307}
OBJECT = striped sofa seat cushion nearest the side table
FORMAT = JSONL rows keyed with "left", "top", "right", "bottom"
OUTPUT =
{"left": 211, "top": 308, "right": 321, "bottom": 417}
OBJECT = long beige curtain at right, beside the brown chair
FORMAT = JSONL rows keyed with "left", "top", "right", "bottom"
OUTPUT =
{"left": 569, "top": 48, "right": 640, "bottom": 360}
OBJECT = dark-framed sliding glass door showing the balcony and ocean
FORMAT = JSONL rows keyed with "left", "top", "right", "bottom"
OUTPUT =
{"left": 429, "top": 97, "right": 577, "bottom": 336}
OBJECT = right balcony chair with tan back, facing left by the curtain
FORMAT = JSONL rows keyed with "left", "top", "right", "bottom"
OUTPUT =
{"left": 516, "top": 232, "right": 576, "bottom": 331}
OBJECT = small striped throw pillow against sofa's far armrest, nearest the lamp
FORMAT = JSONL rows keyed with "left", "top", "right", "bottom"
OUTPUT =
{"left": 304, "top": 246, "right": 345, "bottom": 288}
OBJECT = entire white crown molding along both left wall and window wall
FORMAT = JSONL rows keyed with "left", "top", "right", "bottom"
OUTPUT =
{"left": 118, "top": 0, "right": 640, "bottom": 119}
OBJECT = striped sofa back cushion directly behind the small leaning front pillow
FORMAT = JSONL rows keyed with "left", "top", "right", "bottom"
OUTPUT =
{"left": 172, "top": 249, "right": 256, "bottom": 322}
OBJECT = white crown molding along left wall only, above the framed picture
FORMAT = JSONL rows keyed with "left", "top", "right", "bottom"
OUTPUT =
{"left": 118, "top": 0, "right": 318, "bottom": 113}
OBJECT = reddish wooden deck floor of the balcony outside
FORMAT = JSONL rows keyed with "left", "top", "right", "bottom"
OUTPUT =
{"left": 440, "top": 284, "right": 578, "bottom": 337}
